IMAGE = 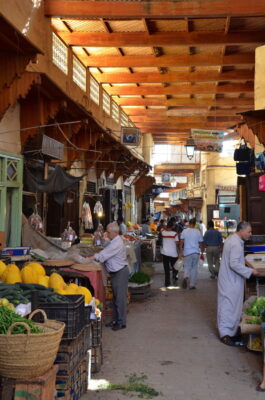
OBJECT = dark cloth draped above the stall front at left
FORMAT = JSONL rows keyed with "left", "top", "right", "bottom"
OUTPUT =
{"left": 25, "top": 165, "right": 86, "bottom": 205}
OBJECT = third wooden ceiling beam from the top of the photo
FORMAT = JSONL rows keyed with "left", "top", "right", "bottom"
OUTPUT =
{"left": 79, "top": 52, "right": 252, "bottom": 68}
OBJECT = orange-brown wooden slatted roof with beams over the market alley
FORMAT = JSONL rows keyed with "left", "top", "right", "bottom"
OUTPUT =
{"left": 45, "top": 0, "right": 265, "bottom": 143}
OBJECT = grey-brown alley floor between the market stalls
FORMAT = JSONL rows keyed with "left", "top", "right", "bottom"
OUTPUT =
{"left": 82, "top": 263, "right": 264, "bottom": 400}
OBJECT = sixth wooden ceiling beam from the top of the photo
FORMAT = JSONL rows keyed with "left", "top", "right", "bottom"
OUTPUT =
{"left": 115, "top": 97, "right": 254, "bottom": 109}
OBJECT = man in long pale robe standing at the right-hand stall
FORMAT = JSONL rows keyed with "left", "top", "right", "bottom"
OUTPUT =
{"left": 217, "top": 221, "right": 259, "bottom": 346}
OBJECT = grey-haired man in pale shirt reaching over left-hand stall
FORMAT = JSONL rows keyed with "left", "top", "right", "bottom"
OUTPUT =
{"left": 86, "top": 222, "right": 129, "bottom": 331}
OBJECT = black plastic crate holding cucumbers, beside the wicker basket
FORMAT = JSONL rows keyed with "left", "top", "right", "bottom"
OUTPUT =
{"left": 38, "top": 295, "right": 87, "bottom": 339}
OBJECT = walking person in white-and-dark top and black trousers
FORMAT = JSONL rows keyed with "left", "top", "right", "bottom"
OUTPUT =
{"left": 161, "top": 221, "right": 179, "bottom": 287}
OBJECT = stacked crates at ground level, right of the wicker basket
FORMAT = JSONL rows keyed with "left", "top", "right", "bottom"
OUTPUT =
{"left": 55, "top": 325, "right": 91, "bottom": 400}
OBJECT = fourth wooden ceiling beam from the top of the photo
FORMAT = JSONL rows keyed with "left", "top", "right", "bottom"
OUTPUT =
{"left": 93, "top": 70, "right": 254, "bottom": 83}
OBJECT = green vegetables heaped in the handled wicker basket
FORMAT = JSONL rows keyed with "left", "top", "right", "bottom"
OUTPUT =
{"left": 0, "top": 306, "right": 43, "bottom": 334}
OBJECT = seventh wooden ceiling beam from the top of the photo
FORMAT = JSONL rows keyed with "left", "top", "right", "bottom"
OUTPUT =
{"left": 123, "top": 107, "right": 248, "bottom": 116}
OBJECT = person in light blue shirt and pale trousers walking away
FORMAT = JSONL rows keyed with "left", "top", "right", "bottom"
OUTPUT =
{"left": 180, "top": 218, "right": 203, "bottom": 289}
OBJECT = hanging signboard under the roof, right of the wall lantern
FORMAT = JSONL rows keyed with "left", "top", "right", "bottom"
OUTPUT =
{"left": 191, "top": 129, "right": 225, "bottom": 153}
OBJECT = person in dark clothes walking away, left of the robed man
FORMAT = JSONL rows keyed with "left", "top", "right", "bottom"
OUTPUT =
{"left": 203, "top": 221, "right": 223, "bottom": 279}
